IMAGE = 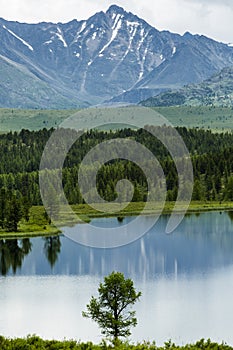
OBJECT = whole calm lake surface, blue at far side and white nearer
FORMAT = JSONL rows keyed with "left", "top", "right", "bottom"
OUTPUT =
{"left": 0, "top": 212, "right": 233, "bottom": 345}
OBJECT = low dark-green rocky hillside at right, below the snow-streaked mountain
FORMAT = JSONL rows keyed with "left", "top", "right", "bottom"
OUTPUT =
{"left": 141, "top": 67, "right": 233, "bottom": 107}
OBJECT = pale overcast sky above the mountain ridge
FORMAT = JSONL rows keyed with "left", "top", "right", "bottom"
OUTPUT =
{"left": 0, "top": 0, "right": 233, "bottom": 43}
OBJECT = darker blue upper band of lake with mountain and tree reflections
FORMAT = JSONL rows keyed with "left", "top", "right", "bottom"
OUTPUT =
{"left": 0, "top": 212, "right": 233, "bottom": 279}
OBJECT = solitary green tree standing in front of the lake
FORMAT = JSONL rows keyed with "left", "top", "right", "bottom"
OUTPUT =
{"left": 83, "top": 272, "right": 141, "bottom": 344}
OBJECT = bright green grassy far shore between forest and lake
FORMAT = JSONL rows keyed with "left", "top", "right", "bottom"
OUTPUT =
{"left": 0, "top": 202, "right": 233, "bottom": 238}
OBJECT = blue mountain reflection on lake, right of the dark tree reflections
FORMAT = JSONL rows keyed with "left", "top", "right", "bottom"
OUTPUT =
{"left": 56, "top": 212, "right": 233, "bottom": 279}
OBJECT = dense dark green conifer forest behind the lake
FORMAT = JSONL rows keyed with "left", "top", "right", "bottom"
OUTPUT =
{"left": 0, "top": 126, "right": 233, "bottom": 232}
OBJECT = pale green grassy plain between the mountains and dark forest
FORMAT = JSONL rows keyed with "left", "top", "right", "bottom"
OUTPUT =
{"left": 0, "top": 106, "right": 233, "bottom": 132}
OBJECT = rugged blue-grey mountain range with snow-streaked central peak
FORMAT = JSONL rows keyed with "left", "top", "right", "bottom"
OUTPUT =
{"left": 0, "top": 5, "right": 233, "bottom": 108}
